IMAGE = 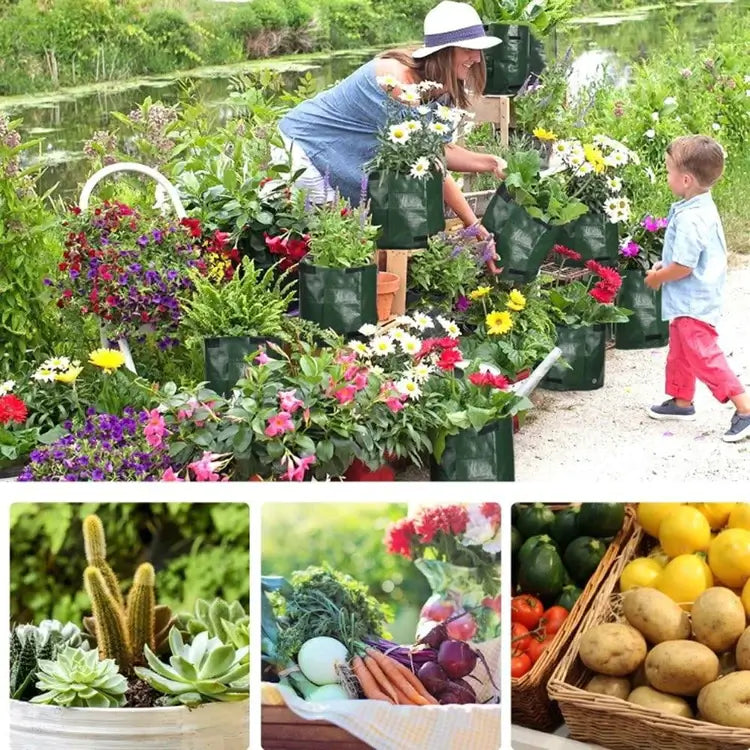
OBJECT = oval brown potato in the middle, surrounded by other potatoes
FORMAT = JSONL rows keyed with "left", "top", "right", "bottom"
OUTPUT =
{"left": 646, "top": 641, "right": 719, "bottom": 695}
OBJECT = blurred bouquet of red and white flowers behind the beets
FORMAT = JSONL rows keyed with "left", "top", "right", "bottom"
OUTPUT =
{"left": 384, "top": 503, "right": 500, "bottom": 642}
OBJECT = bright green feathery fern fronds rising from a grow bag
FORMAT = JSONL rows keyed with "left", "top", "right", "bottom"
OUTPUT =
{"left": 182, "top": 258, "right": 294, "bottom": 340}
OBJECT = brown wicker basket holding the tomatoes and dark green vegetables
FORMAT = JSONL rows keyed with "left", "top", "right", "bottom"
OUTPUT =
{"left": 511, "top": 506, "right": 635, "bottom": 731}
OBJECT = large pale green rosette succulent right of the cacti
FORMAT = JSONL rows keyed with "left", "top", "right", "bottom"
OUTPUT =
{"left": 135, "top": 627, "right": 250, "bottom": 706}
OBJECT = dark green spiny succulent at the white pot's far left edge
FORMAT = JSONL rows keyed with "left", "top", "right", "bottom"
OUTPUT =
{"left": 10, "top": 620, "right": 89, "bottom": 700}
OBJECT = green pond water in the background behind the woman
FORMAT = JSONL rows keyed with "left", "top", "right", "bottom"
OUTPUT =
{"left": 0, "top": 0, "right": 731, "bottom": 199}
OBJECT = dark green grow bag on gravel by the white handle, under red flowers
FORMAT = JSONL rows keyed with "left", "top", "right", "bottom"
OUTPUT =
{"left": 541, "top": 325, "right": 607, "bottom": 391}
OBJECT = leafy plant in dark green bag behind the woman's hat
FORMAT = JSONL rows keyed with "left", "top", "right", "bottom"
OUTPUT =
{"left": 471, "top": 0, "right": 574, "bottom": 96}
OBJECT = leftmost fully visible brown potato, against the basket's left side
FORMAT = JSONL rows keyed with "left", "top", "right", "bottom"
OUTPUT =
{"left": 579, "top": 622, "right": 647, "bottom": 677}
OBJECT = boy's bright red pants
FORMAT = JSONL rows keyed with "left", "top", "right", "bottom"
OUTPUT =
{"left": 665, "top": 317, "right": 745, "bottom": 404}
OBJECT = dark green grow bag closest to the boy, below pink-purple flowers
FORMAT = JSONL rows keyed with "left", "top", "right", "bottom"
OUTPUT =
{"left": 615, "top": 269, "right": 669, "bottom": 349}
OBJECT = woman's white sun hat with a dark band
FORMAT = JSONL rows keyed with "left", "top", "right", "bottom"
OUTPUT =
{"left": 412, "top": 0, "right": 502, "bottom": 58}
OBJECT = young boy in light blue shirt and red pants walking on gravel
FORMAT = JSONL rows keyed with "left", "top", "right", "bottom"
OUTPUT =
{"left": 646, "top": 135, "right": 750, "bottom": 443}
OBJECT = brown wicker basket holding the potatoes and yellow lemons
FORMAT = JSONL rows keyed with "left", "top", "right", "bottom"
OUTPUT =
{"left": 549, "top": 527, "right": 750, "bottom": 750}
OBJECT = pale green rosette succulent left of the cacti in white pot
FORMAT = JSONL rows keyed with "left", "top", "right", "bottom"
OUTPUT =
{"left": 31, "top": 646, "right": 128, "bottom": 708}
